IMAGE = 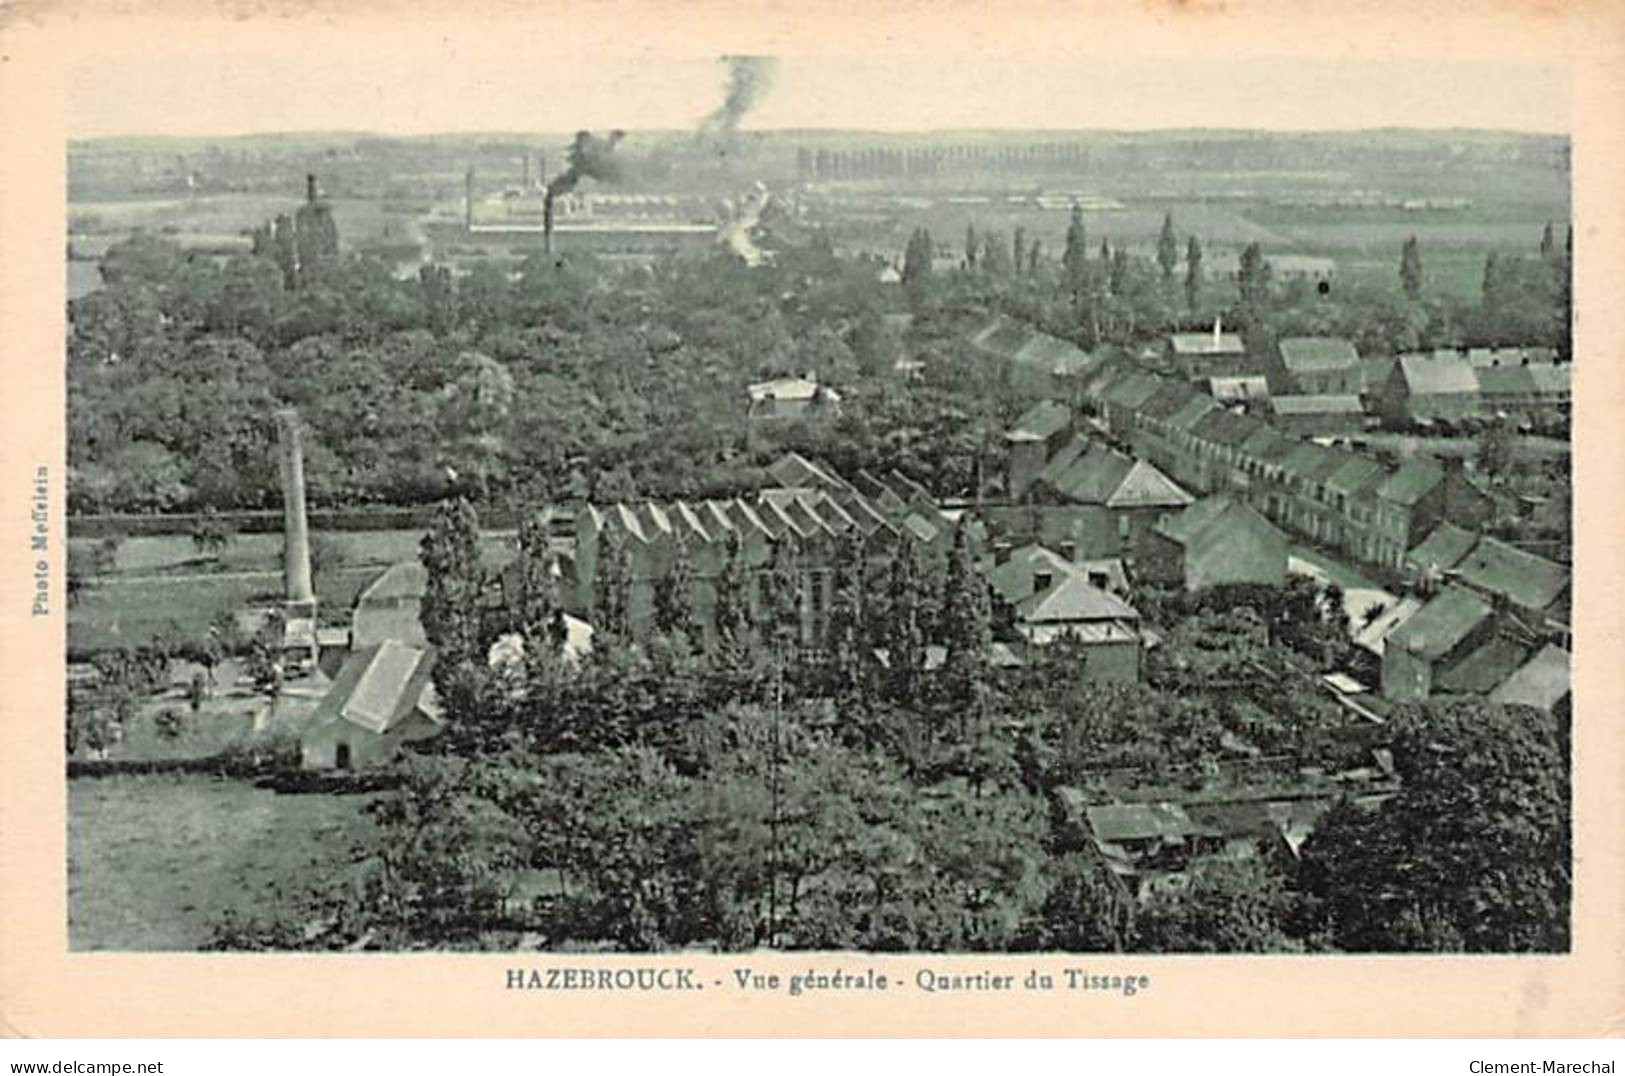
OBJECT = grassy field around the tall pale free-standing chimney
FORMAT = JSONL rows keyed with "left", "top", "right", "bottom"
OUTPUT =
{"left": 68, "top": 530, "right": 514, "bottom": 653}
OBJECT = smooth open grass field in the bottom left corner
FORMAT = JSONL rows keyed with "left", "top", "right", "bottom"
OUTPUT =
{"left": 68, "top": 775, "right": 371, "bottom": 951}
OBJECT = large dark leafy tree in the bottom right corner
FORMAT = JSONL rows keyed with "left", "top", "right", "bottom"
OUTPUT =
{"left": 1302, "top": 701, "right": 1571, "bottom": 952}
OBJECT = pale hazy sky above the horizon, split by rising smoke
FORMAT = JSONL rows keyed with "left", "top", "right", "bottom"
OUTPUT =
{"left": 65, "top": 37, "right": 1571, "bottom": 138}
